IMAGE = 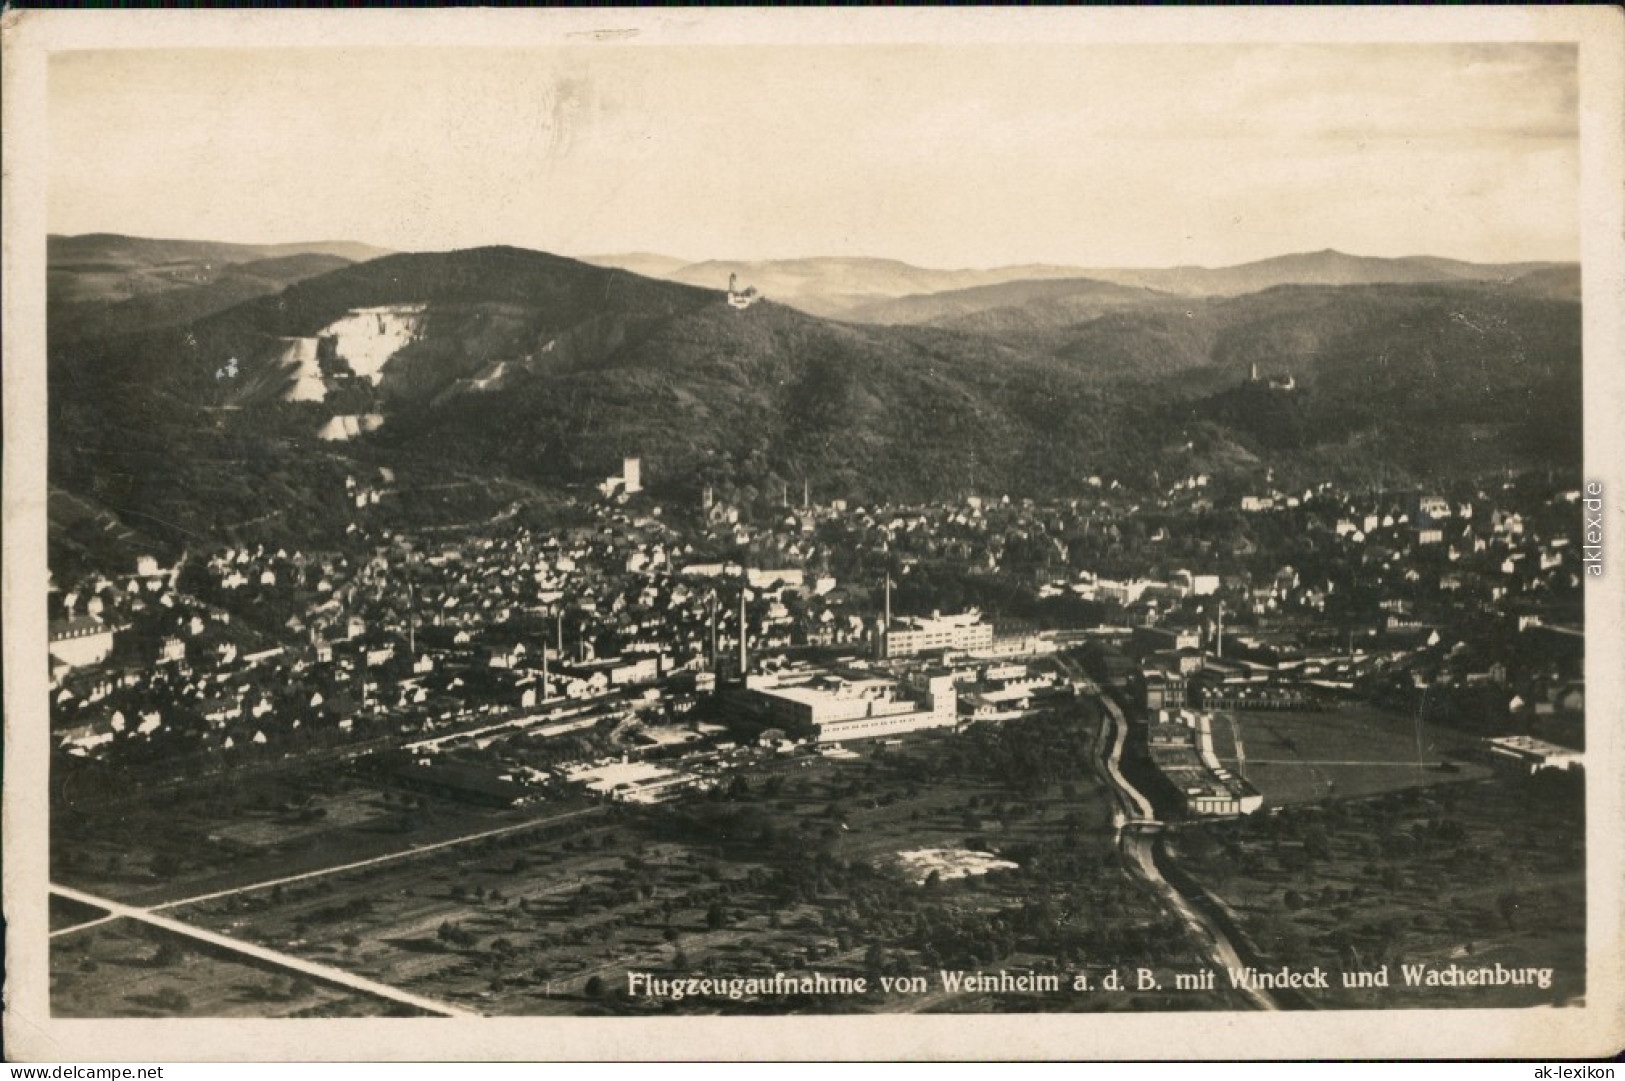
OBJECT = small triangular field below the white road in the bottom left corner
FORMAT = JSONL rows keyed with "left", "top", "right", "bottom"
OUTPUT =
{"left": 50, "top": 920, "right": 411, "bottom": 1018}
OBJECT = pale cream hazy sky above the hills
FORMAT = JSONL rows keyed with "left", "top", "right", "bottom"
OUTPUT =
{"left": 47, "top": 42, "right": 1580, "bottom": 268}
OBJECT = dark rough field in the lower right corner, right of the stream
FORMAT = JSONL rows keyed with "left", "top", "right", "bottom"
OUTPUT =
{"left": 1172, "top": 774, "right": 1586, "bottom": 1008}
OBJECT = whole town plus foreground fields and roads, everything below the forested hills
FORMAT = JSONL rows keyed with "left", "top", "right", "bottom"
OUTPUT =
{"left": 49, "top": 425, "right": 1584, "bottom": 1016}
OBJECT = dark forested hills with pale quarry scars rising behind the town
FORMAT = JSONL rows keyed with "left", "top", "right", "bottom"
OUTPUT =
{"left": 50, "top": 249, "right": 1580, "bottom": 565}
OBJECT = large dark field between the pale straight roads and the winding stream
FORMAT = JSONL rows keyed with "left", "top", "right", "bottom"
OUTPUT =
{"left": 47, "top": 709, "right": 1240, "bottom": 1014}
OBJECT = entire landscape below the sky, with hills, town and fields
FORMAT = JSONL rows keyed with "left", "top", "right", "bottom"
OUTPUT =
{"left": 38, "top": 232, "right": 1584, "bottom": 1018}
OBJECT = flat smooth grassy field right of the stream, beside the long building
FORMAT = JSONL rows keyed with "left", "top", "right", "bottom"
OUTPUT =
{"left": 1212, "top": 704, "right": 1490, "bottom": 806}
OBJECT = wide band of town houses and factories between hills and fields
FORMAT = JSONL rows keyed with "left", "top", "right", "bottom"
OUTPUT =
{"left": 50, "top": 458, "right": 1584, "bottom": 814}
